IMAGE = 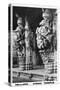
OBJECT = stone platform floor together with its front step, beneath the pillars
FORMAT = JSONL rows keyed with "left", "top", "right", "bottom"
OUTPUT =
{"left": 12, "top": 68, "right": 57, "bottom": 83}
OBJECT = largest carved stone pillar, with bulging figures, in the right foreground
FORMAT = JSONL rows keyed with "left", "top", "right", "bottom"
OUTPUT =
{"left": 36, "top": 9, "right": 57, "bottom": 73}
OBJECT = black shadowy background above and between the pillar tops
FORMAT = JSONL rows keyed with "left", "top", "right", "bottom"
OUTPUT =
{"left": 13, "top": 7, "right": 43, "bottom": 32}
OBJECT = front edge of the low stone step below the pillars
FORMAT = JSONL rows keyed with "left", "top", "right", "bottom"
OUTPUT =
{"left": 13, "top": 72, "right": 57, "bottom": 82}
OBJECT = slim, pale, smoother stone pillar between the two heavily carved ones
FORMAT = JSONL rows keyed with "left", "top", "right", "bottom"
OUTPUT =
{"left": 25, "top": 21, "right": 32, "bottom": 70}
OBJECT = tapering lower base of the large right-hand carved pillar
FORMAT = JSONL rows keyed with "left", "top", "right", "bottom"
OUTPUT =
{"left": 40, "top": 51, "right": 57, "bottom": 74}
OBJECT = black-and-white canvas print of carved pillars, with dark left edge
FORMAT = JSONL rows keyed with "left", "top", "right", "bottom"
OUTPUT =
{"left": 8, "top": 5, "right": 57, "bottom": 85}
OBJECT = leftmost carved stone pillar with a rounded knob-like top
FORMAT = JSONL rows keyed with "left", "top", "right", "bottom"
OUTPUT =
{"left": 13, "top": 17, "right": 25, "bottom": 70}
